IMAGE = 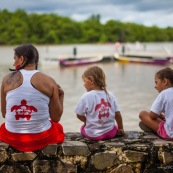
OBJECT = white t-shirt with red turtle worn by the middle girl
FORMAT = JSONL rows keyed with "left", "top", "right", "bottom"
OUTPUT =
{"left": 75, "top": 90, "right": 119, "bottom": 137}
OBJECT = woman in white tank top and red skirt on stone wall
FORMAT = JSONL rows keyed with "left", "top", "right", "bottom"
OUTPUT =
{"left": 0, "top": 44, "right": 64, "bottom": 152}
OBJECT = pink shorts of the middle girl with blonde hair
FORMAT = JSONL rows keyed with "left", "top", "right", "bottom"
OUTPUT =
{"left": 80, "top": 126, "right": 118, "bottom": 140}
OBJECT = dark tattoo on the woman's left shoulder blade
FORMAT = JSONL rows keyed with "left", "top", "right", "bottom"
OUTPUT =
{"left": 6, "top": 71, "right": 22, "bottom": 86}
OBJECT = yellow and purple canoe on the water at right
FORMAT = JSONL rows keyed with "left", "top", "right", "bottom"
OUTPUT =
{"left": 116, "top": 55, "right": 173, "bottom": 65}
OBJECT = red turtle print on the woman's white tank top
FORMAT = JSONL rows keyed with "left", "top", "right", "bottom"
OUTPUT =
{"left": 11, "top": 100, "right": 37, "bottom": 120}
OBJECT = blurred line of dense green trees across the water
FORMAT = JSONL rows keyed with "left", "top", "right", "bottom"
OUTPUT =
{"left": 0, "top": 9, "right": 173, "bottom": 45}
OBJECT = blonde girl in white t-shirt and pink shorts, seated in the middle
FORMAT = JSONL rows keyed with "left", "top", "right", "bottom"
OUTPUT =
{"left": 75, "top": 66, "right": 125, "bottom": 140}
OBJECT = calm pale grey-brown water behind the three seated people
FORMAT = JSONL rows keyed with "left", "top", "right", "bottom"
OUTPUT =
{"left": 0, "top": 43, "right": 172, "bottom": 132}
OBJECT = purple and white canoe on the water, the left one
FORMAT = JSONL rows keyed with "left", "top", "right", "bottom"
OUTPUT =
{"left": 59, "top": 56, "right": 116, "bottom": 67}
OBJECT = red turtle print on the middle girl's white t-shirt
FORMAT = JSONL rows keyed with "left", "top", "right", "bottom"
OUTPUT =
{"left": 95, "top": 98, "right": 111, "bottom": 124}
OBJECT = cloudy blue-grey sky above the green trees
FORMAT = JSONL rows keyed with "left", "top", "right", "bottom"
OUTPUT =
{"left": 0, "top": 0, "right": 173, "bottom": 28}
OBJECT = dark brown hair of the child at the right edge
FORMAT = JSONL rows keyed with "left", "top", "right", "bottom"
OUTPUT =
{"left": 156, "top": 67, "right": 173, "bottom": 85}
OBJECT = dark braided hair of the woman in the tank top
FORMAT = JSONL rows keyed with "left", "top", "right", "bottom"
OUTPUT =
{"left": 10, "top": 44, "right": 39, "bottom": 71}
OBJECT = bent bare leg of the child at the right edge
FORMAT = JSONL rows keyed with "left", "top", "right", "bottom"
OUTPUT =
{"left": 139, "top": 111, "right": 162, "bottom": 133}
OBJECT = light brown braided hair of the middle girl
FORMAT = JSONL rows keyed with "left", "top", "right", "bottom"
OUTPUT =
{"left": 82, "top": 66, "right": 109, "bottom": 99}
